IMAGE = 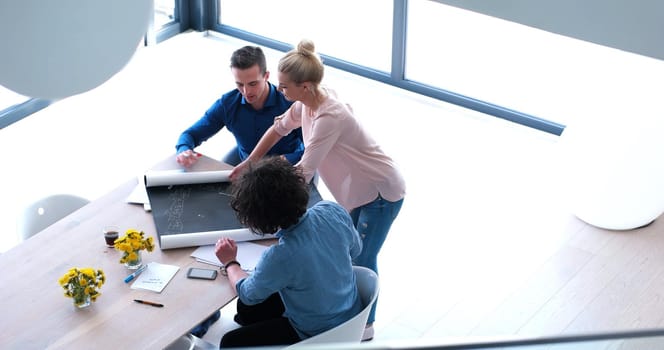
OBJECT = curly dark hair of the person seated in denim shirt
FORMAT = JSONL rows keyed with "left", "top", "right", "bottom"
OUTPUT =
{"left": 230, "top": 156, "right": 309, "bottom": 234}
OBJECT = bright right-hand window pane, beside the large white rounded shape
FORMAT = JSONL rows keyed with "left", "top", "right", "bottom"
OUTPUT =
{"left": 405, "top": 0, "right": 664, "bottom": 129}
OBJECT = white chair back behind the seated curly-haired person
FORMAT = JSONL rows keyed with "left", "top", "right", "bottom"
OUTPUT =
{"left": 289, "top": 266, "right": 379, "bottom": 348}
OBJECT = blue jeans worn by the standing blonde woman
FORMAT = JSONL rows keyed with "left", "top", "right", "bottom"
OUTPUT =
{"left": 350, "top": 195, "right": 403, "bottom": 323}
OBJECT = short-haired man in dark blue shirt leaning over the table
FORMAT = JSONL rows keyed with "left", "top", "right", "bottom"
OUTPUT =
{"left": 175, "top": 46, "right": 304, "bottom": 167}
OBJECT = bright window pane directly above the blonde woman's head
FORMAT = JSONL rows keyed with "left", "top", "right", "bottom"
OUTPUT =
{"left": 219, "top": 0, "right": 393, "bottom": 72}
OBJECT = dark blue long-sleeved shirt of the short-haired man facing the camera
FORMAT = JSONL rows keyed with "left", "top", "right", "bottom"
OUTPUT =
{"left": 175, "top": 84, "right": 304, "bottom": 164}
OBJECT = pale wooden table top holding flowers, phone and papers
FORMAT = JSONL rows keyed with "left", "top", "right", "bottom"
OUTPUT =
{"left": 0, "top": 156, "right": 236, "bottom": 349}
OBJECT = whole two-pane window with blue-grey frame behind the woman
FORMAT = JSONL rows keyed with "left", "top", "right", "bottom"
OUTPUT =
{"left": 213, "top": 0, "right": 664, "bottom": 134}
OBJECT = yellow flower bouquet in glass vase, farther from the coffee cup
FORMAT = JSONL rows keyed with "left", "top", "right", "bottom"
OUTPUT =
{"left": 58, "top": 267, "right": 106, "bottom": 307}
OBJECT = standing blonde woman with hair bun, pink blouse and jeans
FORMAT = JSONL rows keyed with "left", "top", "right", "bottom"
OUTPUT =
{"left": 231, "top": 40, "right": 406, "bottom": 340}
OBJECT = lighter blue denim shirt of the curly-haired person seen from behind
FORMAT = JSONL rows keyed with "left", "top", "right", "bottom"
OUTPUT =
{"left": 235, "top": 201, "right": 362, "bottom": 339}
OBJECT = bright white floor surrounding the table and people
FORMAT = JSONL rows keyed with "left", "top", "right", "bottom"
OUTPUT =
{"left": 0, "top": 33, "right": 664, "bottom": 348}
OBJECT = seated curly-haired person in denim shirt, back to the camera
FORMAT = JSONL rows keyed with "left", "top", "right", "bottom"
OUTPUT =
{"left": 215, "top": 157, "right": 362, "bottom": 348}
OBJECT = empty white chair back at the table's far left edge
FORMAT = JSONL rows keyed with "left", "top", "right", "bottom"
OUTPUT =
{"left": 18, "top": 194, "right": 90, "bottom": 240}
